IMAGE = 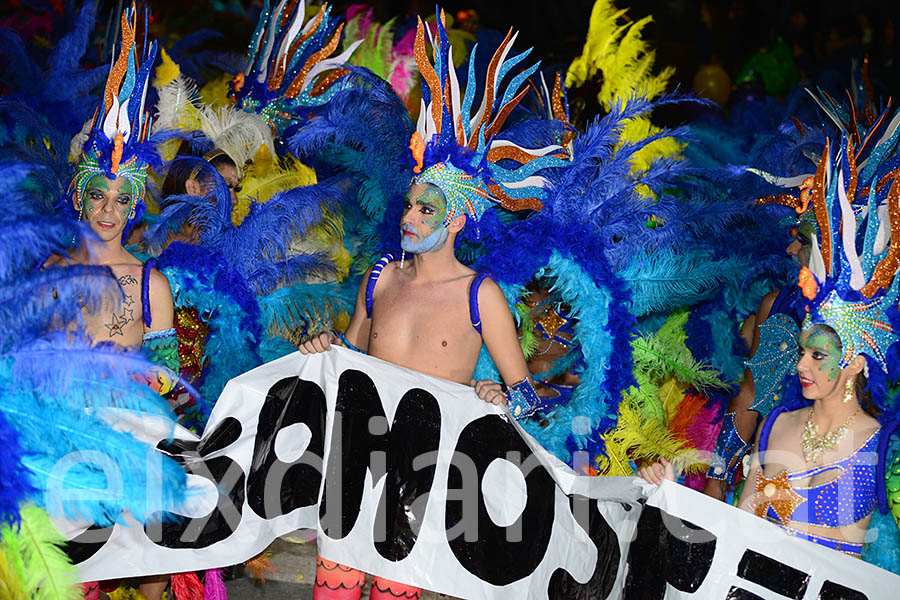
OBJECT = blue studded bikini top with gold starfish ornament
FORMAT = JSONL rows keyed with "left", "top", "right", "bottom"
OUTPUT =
{"left": 757, "top": 411, "right": 881, "bottom": 527}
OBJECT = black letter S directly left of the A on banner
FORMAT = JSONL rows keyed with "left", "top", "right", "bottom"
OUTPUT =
{"left": 144, "top": 417, "right": 244, "bottom": 548}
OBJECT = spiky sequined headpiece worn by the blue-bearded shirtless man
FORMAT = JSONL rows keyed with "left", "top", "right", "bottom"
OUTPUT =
{"left": 410, "top": 12, "right": 568, "bottom": 225}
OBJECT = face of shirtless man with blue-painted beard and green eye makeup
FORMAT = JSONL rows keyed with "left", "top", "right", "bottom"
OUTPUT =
{"left": 400, "top": 183, "right": 450, "bottom": 254}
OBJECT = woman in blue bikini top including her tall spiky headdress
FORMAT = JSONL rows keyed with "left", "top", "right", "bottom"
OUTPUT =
{"left": 641, "top": 129, "right": 900, "bottom": 570}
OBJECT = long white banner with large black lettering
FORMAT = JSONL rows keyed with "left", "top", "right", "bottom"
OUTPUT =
{"left": 58, "top": 348, "right": 900, "bottom": 600}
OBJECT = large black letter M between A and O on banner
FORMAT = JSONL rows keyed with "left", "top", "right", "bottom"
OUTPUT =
{"left": 319, "top": 369, "right": 440, "bottom": 560}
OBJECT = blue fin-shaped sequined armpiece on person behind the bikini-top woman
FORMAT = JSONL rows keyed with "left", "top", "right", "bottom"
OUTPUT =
{"left": 744, "top": 313, "right": 800, "bottom": 417}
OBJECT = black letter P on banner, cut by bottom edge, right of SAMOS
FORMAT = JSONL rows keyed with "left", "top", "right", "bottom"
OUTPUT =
{"left": 623, "top": 506, "right": 716, "bottom": 600}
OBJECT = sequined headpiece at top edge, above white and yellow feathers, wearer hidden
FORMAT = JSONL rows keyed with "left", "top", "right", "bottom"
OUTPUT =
{"left": 231, "top": 0, "right": 362, "bottom": 136}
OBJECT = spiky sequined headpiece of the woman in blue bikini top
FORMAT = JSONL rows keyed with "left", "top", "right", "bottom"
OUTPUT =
{"left": 800, "top": 134, "right": 900, "bottom": 373}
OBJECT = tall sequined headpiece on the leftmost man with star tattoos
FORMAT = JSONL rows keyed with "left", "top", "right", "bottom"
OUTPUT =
{"left": 69, "top": 5, "right": 156, "bottom": 219}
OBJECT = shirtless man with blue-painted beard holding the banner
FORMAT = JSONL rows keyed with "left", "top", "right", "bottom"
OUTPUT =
{"left": 300, "top": 182, "right": 537, "bottom": 600}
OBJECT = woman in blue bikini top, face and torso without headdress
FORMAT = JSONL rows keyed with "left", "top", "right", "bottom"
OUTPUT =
{"left": 740, "top": 324, "right": 881, "bottom": 555}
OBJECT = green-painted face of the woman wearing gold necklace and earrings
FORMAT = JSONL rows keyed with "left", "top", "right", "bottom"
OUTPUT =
{"left": 797, "top": 325, "right": 843, "bottom": 400}
